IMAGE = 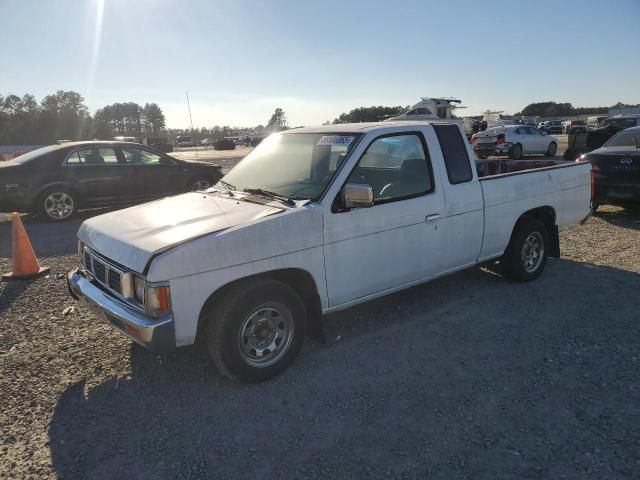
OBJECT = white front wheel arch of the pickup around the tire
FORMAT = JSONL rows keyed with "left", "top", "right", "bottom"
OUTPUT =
{"left": 196, "top": 268, "right": 325, "bottom": 343}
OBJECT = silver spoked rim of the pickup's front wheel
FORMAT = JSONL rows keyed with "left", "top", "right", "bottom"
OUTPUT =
{"left": 238, "top": 302, "right": 293, "bottom": 367}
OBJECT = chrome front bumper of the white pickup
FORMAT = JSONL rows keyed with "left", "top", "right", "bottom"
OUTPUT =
{"left": 67, "top": 268, "right": 176, "bottom": 353}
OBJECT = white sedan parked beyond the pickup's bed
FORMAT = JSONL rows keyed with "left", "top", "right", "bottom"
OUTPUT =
{"left": 471, "top": 125, "right": 558, "bottom": 160}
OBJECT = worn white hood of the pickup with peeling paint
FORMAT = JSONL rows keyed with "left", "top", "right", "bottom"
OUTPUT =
{"left": 78, "top": 192, "right": 283, "bottom": 273}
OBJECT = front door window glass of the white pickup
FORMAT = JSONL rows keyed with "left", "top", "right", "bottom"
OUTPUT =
{"left": 347, "top": 134, "right": 433, "bottom": 203}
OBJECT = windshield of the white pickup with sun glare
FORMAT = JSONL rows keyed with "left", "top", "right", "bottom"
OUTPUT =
{"left": 223, "top": 133, "right": 359, "bottom": 200}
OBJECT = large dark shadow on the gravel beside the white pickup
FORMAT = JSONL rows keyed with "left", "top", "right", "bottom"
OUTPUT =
{"left": 49, "top": 260, "right": 640, "bottom": 479}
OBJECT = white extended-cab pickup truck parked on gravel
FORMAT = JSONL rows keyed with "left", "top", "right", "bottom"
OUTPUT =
{"left": 68, "top": 122, "right": 590, "bottom": 382}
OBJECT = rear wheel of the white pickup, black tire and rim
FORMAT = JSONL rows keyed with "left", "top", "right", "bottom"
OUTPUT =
{"left": 500, "top": 218, "right": 549, "bottom": 282}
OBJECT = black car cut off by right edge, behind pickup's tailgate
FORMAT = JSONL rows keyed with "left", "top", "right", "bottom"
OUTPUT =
{"left": 580, "top": 126, "right": 640, "bottom": 210}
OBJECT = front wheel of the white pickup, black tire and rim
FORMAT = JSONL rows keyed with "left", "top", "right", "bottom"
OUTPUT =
{"left": 205, "top": 279, "right": 306, "bottom": 383}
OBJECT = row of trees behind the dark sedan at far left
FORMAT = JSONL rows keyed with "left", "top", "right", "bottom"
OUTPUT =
{"left": 0, "top": 90, "right": 165, "bottom": 145}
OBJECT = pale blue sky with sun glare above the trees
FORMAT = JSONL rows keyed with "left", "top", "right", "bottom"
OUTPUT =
{"left": 0, "top": 0, "right": 640, "bottom": 127}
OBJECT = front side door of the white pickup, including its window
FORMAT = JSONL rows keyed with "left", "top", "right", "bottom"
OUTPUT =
{"left": 324, "top": 132, "right": 444, "bottom": 307}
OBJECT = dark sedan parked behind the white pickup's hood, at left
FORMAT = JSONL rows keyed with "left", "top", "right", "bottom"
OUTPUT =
{"left": 0, "top": 142, "right": 222, "bottom": 221}
